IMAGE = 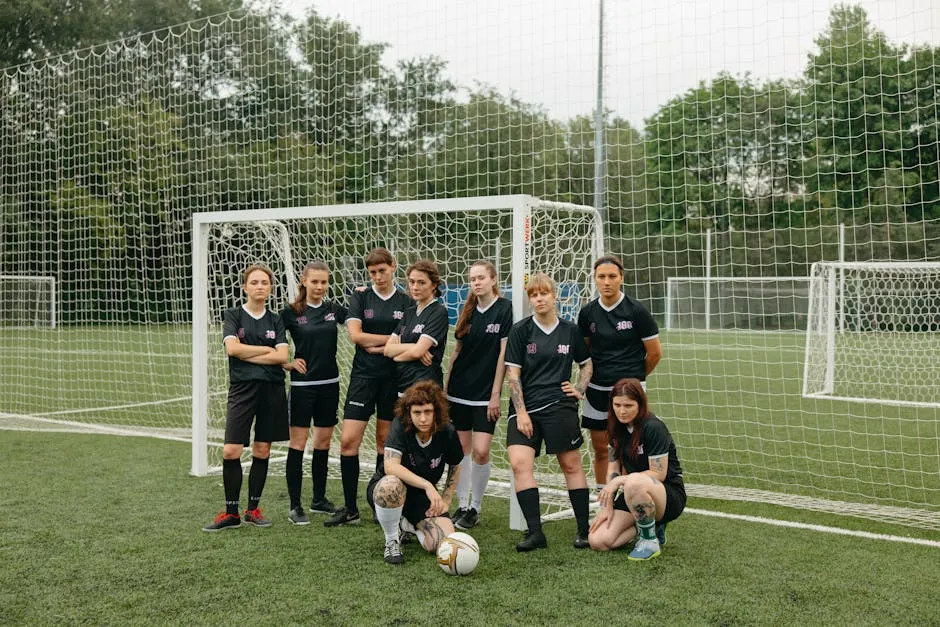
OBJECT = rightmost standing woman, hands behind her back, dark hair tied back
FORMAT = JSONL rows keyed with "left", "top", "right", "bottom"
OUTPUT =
{"left": 578, "top": 255, "right": 663, "bottom": 490}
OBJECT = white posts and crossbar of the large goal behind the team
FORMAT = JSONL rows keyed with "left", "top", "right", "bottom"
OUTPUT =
{"left": 190, "top": 195, "right": 603, "bottom": 529}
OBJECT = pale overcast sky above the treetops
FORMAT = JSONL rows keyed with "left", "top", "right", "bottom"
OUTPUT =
{"left": 283, "top": 0, "right": 940, "bottom": 125}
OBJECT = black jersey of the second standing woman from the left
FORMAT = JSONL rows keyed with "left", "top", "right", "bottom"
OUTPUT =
{"left": 281, "top": 300, "right": 346, "bottom": 385}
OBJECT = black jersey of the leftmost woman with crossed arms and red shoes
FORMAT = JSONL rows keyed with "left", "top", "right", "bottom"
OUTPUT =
{"left": 222, "top": 305, "right": 287, "bottom": 383}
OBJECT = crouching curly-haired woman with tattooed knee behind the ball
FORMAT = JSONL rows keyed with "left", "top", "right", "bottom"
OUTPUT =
{"left": 366, "top": 380, "right": 463, "bottom": 564}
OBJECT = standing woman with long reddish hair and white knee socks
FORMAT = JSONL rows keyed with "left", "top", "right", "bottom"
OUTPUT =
{"left": 446, "top": 261, "right": 512, "bottom": 529}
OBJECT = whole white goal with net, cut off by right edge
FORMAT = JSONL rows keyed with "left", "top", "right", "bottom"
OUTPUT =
{"left": 803, "top": 262, "right": 940, "bottom": 407}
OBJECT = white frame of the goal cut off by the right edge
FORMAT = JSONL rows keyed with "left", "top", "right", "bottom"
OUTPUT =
{"left": 802, "top": 261, "right": 940, "bottom": 408}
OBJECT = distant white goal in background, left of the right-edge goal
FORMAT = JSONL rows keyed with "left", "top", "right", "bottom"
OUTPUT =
{"left": 665, "top": 276, "right": 809, "bottom": 331}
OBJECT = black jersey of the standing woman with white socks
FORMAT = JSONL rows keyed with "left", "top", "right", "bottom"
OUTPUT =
{"left": 447, "top": 298, "right": 512, "bottom": 407}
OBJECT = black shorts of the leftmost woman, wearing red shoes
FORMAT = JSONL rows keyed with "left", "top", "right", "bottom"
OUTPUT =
{"left": 225, "top": 381, "right": 290, "bottom": 446}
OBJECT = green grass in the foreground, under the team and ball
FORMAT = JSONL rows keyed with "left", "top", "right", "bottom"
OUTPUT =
{"left": 0, "top": 431, "right": 940, "bottom": 625}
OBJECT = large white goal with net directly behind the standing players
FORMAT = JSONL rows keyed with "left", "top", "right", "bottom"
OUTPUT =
{"left": 191, "top": 195, "right": 603, "bottom": 528}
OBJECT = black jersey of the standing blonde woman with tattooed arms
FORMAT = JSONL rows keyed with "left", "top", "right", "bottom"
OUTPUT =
{"left": 506, "top": 316, "right": 591, "bottom": 413}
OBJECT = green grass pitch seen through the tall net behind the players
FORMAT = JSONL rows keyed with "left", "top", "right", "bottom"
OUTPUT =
{"left": 0, "top": 326, "right": 940, "bottom": 516}
